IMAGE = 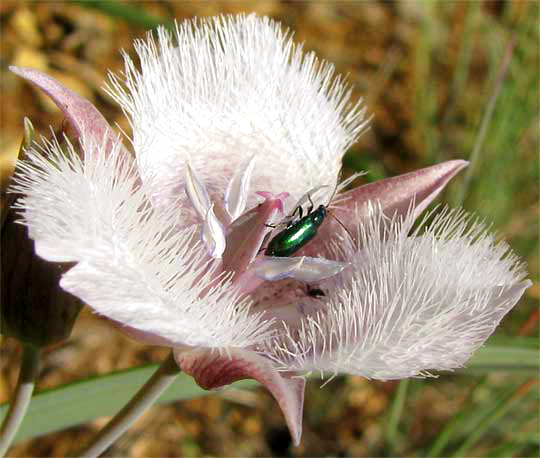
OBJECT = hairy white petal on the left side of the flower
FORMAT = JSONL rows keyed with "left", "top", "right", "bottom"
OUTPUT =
{"left": 11, "top": 134, "right": 271, "bottom": 347}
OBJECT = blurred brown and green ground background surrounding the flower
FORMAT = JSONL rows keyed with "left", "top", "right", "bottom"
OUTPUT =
{"left": 0, "top": 0, "right": 540, "bottom": 457}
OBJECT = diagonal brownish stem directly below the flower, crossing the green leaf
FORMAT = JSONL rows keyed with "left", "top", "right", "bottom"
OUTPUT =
{"left": 78, "top": 351, "right": 180, "bottom": 457}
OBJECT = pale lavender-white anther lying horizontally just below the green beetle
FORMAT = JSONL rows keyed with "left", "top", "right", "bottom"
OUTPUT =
{"left": 251, "top": 256, "right": 348, "bottom": 283}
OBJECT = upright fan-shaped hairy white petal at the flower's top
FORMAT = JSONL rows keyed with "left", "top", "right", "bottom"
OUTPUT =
{"left": 107, "top": 14, "right": 367, "bottom": 212}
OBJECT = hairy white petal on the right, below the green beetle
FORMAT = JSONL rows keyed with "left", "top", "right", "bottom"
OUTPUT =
{"left": 263, "top": 204, "right": 530, "bottom": 380}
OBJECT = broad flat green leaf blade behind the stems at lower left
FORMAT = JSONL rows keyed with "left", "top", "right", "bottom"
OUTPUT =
{"left": 0, "top": 364, "right": 256, "bottom": 442}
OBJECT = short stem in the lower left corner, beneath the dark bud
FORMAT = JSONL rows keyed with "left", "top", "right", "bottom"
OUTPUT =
{"left": 0, "top": 343, "right": 39, "bottom": 457}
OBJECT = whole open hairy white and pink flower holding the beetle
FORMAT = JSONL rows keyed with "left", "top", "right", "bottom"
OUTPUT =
{"left": 12, "top": 15, "right": 530, "bottom": 444}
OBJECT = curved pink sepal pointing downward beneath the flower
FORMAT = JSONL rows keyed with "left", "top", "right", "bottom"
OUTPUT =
{"left": 174, "top": 348, "right": 305, "bottom": 445}
